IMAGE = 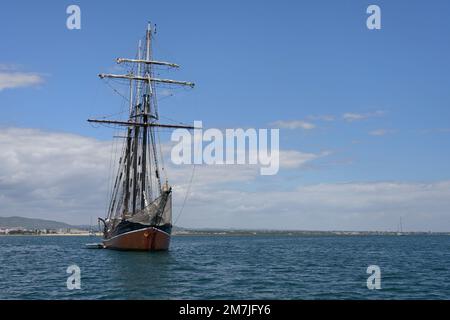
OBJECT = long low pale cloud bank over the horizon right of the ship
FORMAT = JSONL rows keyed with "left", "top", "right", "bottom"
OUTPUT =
{"left": 180, "top": 181, "right": 450, "bottom": 231}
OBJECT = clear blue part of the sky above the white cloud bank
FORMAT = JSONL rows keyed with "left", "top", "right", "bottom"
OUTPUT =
{"left": 0, "top": 1, "right": 450, "bottom": 229}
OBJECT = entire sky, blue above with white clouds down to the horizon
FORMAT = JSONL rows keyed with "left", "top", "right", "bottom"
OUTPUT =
{"left": 0, "top": 1, "right": 450, "bottom": 231}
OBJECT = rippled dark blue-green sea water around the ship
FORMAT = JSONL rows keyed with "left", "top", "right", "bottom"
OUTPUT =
{"left": 0, "top": 236, "right": 450, "bottom": 299}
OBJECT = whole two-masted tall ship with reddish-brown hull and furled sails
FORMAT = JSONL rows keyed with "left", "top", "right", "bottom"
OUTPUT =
{"left": 88, "top": 24, "right": 194, "bottom": 251}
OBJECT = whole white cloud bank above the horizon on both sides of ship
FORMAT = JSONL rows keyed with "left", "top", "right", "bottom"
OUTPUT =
{"left": 0, "top": 128, "right": 450, "bottom": 231}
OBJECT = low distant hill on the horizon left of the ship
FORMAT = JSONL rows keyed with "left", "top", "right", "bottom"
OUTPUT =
{"left": 0, "top": 217, "right": 89, "bottom": 230}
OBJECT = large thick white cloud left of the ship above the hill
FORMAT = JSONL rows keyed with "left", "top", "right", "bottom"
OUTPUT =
{"left": 0, "top": 128, "right": 111, "bottom": 222}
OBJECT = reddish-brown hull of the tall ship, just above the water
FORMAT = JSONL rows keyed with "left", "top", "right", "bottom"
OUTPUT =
{"left": 103, "top": 222, "right": 170, "bottom": 251}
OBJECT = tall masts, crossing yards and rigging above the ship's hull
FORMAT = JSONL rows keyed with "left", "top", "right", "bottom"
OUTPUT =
{"left": 88, "top": 24, "right": 194, "bottom": 219}
